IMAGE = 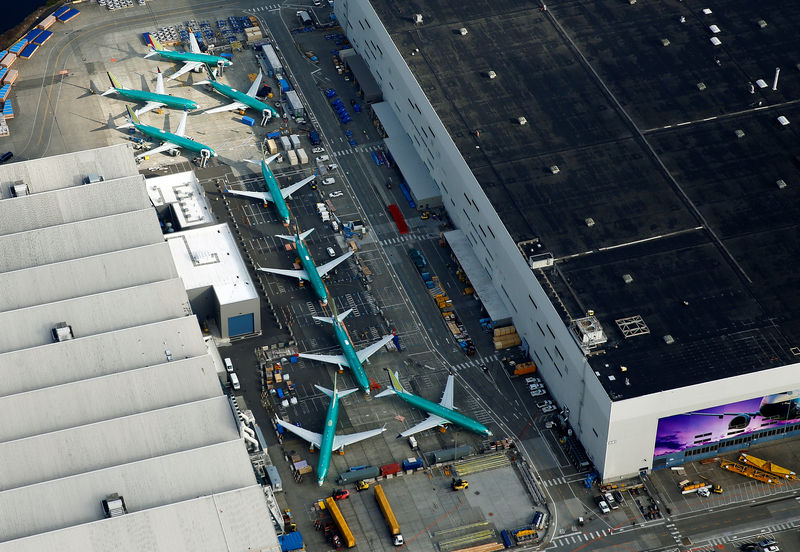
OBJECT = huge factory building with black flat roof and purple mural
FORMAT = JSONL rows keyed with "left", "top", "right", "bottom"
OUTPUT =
{"left": 335, "top": 0, "right": 800, "bottom": 480}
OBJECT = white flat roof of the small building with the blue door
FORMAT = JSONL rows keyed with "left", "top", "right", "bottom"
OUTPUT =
{"left": 167, "top": 224, "right": 258, "bottom": 304}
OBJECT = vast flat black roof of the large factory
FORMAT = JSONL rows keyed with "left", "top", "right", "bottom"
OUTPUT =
{"left": 371, "top": 0, "right": 800, "bottom": 400}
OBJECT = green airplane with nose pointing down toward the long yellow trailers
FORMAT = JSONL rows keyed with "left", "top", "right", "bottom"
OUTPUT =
{"left": 275, "top": 374, "right": 386, "bottom": 487}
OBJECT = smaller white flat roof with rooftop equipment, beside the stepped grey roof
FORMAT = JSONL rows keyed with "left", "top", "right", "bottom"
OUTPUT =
{"left": 147, "top": 171, "right": 215, "bottom": 230}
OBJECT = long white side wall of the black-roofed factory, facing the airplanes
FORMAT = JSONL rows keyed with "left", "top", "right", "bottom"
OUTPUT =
{"left": 335, "top": 0, "right": 616, "bottom": 476}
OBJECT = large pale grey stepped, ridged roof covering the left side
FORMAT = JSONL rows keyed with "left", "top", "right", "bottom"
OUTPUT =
{"left": 0, "top": 144, "right": 280, "bottom": 552}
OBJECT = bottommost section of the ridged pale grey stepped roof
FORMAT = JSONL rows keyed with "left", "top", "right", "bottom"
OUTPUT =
{"left": 0, "top": 485, "right": 281, "bottom": 552}
